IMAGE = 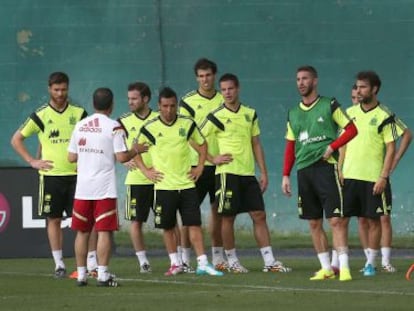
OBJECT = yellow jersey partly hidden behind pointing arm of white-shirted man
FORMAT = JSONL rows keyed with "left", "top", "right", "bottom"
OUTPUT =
{"left": 118, "top": 110, "right": 158, "bottom": 185}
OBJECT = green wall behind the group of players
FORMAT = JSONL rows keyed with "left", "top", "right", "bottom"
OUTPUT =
{"left": 0, "top": 0, "right": 414, "bottom": 234}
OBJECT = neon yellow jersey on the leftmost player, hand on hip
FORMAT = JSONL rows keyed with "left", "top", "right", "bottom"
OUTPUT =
{"left": 19, "top": 103, "right": 87, "bottom": 176}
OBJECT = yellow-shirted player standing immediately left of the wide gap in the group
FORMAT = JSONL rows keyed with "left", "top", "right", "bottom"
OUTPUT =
{"left": 202, "top": 73, "right": 290, "bottom": 273}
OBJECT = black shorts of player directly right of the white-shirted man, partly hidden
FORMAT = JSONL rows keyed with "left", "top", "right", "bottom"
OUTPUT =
{"left": 125, "top": 184, "right": 154, "bottom": 223}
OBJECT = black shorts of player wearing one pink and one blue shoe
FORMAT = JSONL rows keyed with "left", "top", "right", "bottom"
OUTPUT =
{"left": 154, "top": 188, "right": 201, "bottom": 229}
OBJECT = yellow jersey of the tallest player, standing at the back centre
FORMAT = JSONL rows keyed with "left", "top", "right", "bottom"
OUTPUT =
{"left": 180, "top": 90, "right": 223, "bottom": 165}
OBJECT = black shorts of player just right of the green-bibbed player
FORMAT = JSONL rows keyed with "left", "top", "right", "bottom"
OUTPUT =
{"left": 343, "top": 179, "right": 392, "bottom": 219}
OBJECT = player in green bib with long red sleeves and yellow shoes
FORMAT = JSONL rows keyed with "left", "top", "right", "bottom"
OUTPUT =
{"left": 282, "top": 66, "right": 357, "bottom": 281}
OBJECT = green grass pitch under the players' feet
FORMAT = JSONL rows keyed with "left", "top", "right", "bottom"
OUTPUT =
{"left": 0, "top": 255, "right": 414, "bottom": 311}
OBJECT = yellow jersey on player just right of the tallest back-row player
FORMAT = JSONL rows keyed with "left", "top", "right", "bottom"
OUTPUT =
{"left": 201, "top": 105, "right": 260, "bottom": 176}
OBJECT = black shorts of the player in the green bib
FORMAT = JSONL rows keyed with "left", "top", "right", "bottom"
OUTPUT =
{"left": 298, "top": 160, "right": 343, "bottom": 219}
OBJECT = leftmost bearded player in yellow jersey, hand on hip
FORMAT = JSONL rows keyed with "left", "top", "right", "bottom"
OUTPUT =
{"left": 11, "top": 72, "right": 87, "bottom": 278}
